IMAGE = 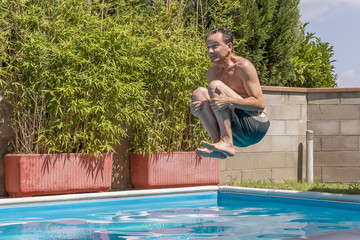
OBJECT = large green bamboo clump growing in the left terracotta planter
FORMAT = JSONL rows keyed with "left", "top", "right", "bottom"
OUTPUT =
{"left": 0, "top": 0, "right": 150, "bottom": 153}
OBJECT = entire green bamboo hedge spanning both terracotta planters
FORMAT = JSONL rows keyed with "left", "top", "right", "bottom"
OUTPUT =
{"left": 0, "top": 0, "right": 209, "bottom": 153}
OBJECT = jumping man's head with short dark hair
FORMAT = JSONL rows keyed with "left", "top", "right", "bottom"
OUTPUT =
{"left": 206, "top": 27, "right": 233, "bottom": 63}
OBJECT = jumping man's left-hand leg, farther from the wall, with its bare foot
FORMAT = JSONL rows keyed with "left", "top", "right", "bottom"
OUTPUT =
{"left": 190, "top": 87, "right": 226, "bottom": 159}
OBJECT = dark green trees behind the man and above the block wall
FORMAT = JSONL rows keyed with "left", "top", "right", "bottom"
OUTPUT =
{"left": 184, "top": 0, "right": 337, "bottom": 87}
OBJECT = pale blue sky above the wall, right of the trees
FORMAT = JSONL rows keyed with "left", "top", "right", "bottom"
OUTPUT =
{"left": 300, "top": 0, "right": 360, "bottom": 87}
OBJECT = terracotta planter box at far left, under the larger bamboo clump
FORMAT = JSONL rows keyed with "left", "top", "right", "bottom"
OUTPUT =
{"left": 4, "top": 153, "right": 113, "bottom": 197}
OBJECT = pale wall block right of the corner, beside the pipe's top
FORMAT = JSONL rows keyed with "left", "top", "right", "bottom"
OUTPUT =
{"left": 308, "top": 120, "right": 340, "bottom": 136}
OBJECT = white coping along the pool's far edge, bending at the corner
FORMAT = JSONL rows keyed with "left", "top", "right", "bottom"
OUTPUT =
{"left": 0, "top": 186, "right": 360, "bottom": 206}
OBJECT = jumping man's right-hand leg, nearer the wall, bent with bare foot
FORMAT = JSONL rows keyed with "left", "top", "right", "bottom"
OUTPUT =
{"left": 203, "top": 80, "right": 239, "bottom": 156}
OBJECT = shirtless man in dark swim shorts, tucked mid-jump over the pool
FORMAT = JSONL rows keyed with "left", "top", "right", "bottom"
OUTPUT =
{"left": 190, "top": 28, "right": 270, "bottom": 159}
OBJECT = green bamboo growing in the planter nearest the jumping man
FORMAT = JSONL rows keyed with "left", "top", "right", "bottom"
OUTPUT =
{"left": 130, "top": 1, "right": 210, "bottom": 153}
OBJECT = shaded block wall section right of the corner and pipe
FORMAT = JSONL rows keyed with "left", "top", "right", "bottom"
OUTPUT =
{"left": 308, "top": 88, "right": 360, "bottom": 183}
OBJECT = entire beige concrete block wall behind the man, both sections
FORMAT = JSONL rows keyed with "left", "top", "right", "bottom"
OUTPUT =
{"left": 220, "top": 87, "right": 360, "bottom": 185}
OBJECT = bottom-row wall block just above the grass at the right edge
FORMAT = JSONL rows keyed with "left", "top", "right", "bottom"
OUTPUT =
{"left": 322, "top": 167, "right": 360, "bottom": 183}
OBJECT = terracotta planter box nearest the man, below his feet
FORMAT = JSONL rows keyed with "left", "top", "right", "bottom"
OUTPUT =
{"left": 130, "top": 152, "right": 221, "bottom": 189}
